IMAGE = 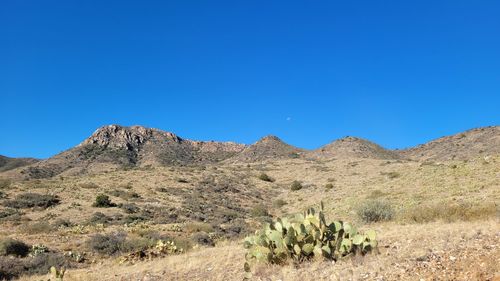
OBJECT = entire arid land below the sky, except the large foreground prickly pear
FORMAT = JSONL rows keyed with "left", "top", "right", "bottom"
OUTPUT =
{"left": 0, "top": 125, "right": 500, "bottom": 281}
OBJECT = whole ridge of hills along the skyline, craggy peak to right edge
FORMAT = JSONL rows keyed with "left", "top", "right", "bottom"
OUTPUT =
{"left": 0, "top": 125, "right": 500, "bottom": 178}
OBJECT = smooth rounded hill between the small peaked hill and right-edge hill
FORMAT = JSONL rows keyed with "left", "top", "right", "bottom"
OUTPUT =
{"left": 309, "top": 137, "right": 401, "bottom": 159}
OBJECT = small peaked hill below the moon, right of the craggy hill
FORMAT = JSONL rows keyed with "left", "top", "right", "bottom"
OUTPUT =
{"left": 228, "top": 136, "right": 304, "bottom": 162}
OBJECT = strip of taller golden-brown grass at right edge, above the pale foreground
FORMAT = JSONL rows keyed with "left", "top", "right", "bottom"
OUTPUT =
{"left": 402, "top": 202, "right": 500, "bottom": 223}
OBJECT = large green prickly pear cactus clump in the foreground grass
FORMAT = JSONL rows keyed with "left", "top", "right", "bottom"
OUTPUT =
{"left": 244, "top": 203, "right": 377, "bottom": 269}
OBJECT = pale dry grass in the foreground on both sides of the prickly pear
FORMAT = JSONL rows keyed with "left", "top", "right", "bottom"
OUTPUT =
{"left": 17, "top": 221, "right": 500, "bottom": 281}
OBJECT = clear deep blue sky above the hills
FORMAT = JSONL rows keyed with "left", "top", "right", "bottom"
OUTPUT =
{"left": 0, "top": 0, "right": 500, "bottom": 158}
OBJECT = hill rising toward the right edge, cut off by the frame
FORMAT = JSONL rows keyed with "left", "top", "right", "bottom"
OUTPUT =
{"left": 400, "top": 126, "right": 500, "bottom": 161}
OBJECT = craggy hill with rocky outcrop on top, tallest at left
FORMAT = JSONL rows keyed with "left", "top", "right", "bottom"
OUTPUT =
{"left": 13, "top": 125, "right": 245, "bottom": 178}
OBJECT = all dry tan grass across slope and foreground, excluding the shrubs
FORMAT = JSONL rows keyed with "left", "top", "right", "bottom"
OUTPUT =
{"left": 0, "top": 156, "right": 500, "bottom": 280}
